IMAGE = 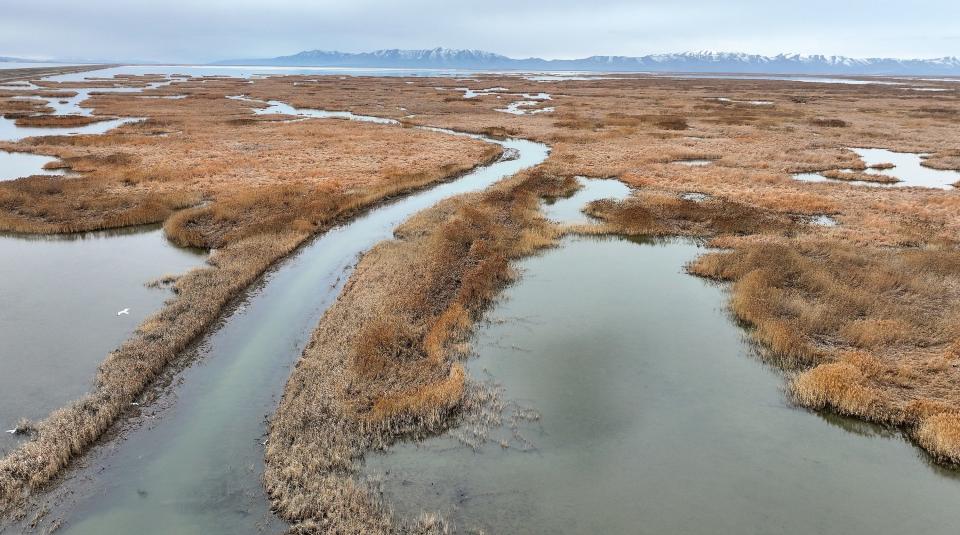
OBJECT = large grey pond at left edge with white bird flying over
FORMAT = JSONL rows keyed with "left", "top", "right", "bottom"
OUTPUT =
{"left": 0, "top": 227, "right": 206, "bottom": 450}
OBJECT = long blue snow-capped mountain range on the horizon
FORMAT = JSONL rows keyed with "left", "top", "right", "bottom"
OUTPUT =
{"left": 217, "top": 48, "right": 960, "bottom": 75}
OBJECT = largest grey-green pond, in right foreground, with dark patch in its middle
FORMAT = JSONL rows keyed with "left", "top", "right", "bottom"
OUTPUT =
{"left": 365, "top": 181, "right": 960, "bottom": 535}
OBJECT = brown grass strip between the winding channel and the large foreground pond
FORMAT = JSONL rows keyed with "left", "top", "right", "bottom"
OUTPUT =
{"left": 265, "top": 168, "right": 570, "bottom": 533}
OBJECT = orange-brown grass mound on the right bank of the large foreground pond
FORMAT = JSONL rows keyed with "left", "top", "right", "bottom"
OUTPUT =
{"left": 690, "top": 239, "right": 960, "bottom": 462}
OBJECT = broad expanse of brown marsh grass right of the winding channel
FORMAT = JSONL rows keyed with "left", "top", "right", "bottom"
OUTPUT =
{"left": 249, "top": 76, "right": 960, "bottom": 468}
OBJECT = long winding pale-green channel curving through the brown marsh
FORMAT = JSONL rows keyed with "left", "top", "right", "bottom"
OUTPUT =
{"left": 20, "top": 102, "right": 549, "bottom": 534}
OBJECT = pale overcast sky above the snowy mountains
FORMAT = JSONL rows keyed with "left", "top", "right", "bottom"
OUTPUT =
{"left": 0, "top": 0, "right": 960, "bottom": 62}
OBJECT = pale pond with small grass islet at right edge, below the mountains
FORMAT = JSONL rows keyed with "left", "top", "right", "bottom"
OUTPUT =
{"left": 793, "top": 148, "right": 960, "bottom": 190}
